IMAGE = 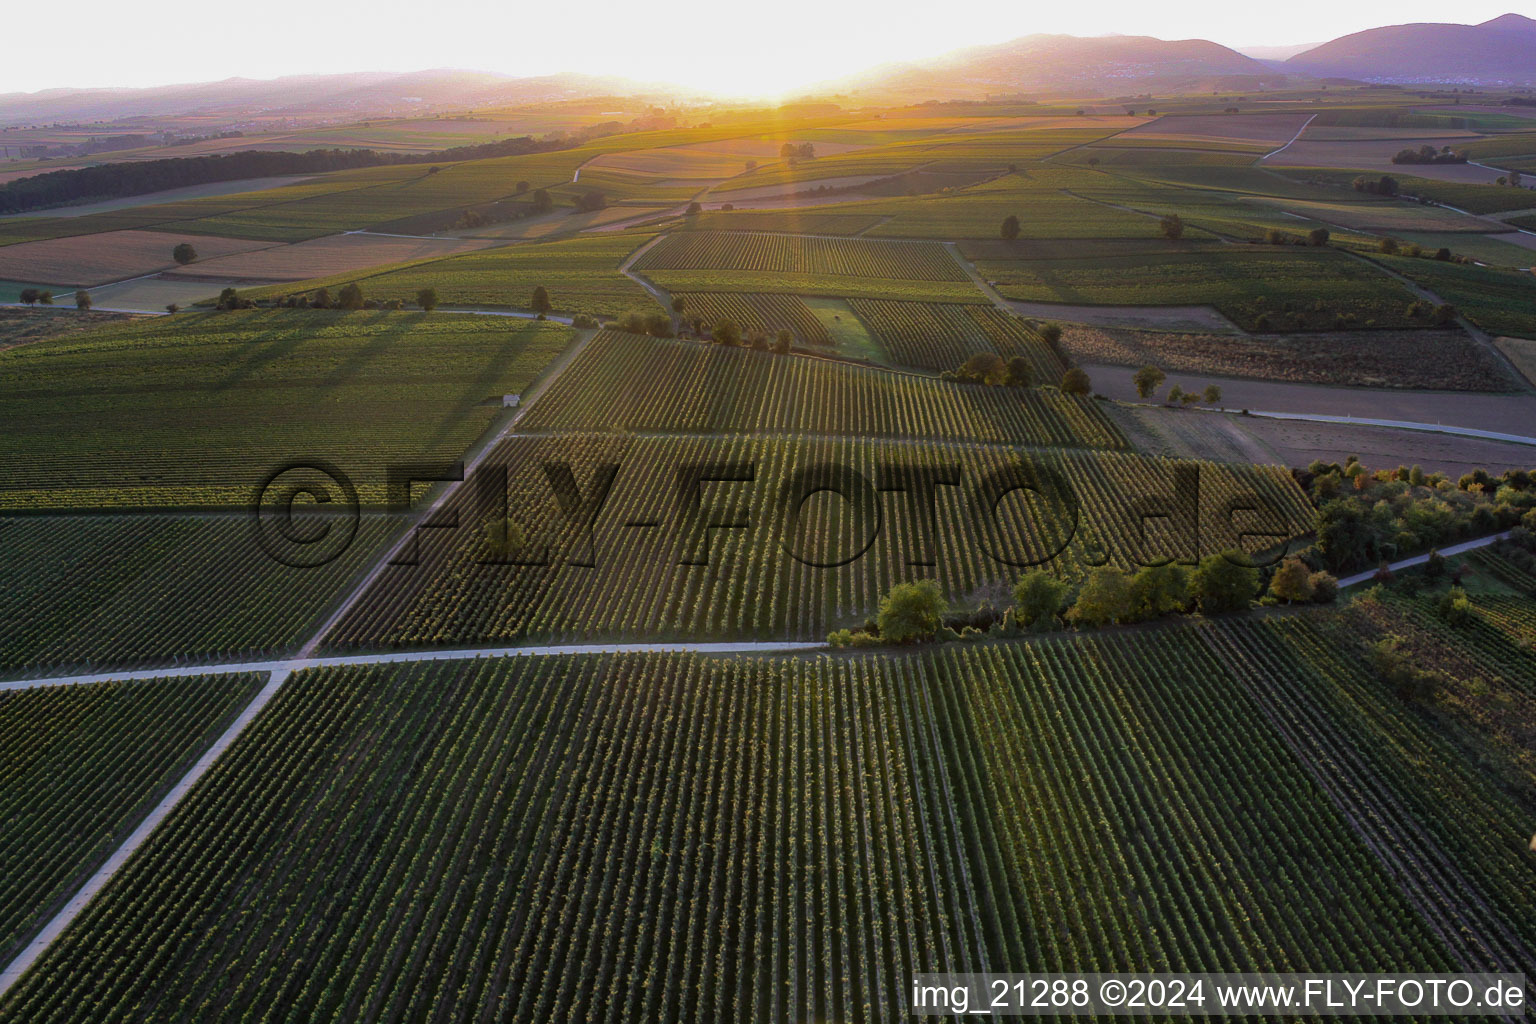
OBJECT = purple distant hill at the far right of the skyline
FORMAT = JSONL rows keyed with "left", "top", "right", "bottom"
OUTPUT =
{"left": 1284, "top": 14, "right": 1536, "bottom": 86}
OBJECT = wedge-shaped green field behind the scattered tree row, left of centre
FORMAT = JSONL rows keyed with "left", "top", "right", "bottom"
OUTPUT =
{"left": 247, "top": 233, "right": 654, "bottom": 316}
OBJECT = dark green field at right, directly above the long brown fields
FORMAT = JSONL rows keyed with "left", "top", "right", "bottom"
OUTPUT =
{"left": 977, "top": 247, "right": 1427, "bottom": 330}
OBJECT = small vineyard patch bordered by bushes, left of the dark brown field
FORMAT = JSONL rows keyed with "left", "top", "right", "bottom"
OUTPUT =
{"left": 848, "top": 299, "right": 1066, "bottom": 384}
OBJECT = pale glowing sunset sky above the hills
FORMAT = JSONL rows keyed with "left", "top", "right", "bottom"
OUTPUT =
{"left": 0, "top": 0, "right": 1536, "bottom": 95}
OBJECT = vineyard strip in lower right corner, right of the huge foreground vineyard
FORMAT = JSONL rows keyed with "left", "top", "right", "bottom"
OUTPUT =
{"left": 1209, "top": 617, "right": 1536, "bottom": 972}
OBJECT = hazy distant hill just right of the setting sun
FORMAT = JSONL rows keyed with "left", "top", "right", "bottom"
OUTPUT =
{"left": 819, "top": 35, "right": 1286, "bottom": 103}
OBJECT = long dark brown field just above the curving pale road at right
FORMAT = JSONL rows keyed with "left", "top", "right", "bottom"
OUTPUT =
{"left": 1061, "top": 324, "right": 1521, "bottom": 391}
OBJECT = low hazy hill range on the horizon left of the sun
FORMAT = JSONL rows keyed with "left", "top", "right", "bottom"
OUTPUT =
{"left": 0, "top": 71, "right": 691, "bottom": 124}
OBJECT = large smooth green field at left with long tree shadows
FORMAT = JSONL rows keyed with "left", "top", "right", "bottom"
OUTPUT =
{"left": 0, "top": 310, "right": 571, "bottom": 510}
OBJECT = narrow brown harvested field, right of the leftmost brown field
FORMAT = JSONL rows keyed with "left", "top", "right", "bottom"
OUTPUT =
{"left": 169, "top": 232, "right": 495, "bottom": 281}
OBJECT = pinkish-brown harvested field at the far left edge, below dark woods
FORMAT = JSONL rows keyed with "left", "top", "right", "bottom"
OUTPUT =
{"left": 0, "top": 230, "right": 272, "bottom": 289}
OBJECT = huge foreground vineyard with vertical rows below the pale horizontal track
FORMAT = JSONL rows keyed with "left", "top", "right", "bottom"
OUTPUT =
{"left": 0, "top": 647, "right": 1453, "bottom": 1024}
